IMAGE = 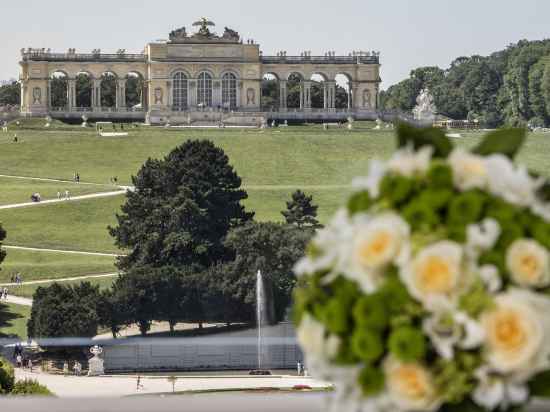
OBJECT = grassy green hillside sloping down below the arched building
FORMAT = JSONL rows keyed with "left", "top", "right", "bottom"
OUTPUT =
{"left": 0, "top": 124, "right": 550, "bottom": 286}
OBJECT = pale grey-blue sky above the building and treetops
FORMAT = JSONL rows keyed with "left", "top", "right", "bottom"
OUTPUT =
{"left": 0, "top": 0, "right": 550, "bottom": 88}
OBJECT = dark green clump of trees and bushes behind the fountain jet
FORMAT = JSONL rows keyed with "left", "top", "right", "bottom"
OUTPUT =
{"left": 27, "top": 141, "right": 319, "bottom": 338}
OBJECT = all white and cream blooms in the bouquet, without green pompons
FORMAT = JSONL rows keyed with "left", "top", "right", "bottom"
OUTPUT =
{"left": 295, "top": 147, "right": 550, "bottom": 412}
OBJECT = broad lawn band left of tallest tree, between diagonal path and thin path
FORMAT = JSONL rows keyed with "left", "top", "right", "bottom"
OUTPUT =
{"left": 0, "top": 195, "right": 124, "bottom": 253}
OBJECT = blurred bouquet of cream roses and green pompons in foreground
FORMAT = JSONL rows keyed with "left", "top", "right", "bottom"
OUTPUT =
{"left": 295, "top": 125, "right": 550, "bottom": 412}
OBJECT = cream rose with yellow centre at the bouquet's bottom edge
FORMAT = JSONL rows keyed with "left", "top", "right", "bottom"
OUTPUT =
{"left": 384, "top": 359, "right": 441, "bottom": 411}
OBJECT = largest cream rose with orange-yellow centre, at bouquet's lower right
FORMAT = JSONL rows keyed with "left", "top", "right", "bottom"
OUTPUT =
{"left": 481, "top": 289, "right": 550, "bottom": 381}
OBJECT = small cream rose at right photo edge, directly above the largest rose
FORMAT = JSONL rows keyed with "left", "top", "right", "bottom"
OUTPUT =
{"left": 506, "top": 239, "right": 550, "bottom": 287}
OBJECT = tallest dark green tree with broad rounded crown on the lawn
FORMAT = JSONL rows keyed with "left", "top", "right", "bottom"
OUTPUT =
{"left": 110, "top": 140, "right": 253, "bottom": 272}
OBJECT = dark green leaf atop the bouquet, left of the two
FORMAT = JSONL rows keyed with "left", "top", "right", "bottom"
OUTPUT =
{"left": 397, "top": 123, "right": 453, "bottom": 158}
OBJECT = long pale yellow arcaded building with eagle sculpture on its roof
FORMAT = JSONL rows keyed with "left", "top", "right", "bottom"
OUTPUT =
{"left": 20, "top": 19, "right": 381, "bottom": 124}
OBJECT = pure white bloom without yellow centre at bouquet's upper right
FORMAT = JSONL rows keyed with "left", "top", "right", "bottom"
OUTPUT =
{"left": 486, "top": 154, "right": 540, "bottom": 206}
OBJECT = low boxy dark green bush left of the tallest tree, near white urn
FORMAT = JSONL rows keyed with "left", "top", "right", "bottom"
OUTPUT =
{"left": 27, "top": 282, "right": 100, "bottom": 338}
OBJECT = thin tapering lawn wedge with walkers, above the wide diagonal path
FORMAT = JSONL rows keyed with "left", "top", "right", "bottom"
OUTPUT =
{"left": 0, "top": 177, "right": 117, "bottom": 206}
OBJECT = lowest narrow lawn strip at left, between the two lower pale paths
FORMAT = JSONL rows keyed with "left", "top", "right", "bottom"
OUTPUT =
{"left": 0, "top": 249, "right": 117, "bottom": 283}
